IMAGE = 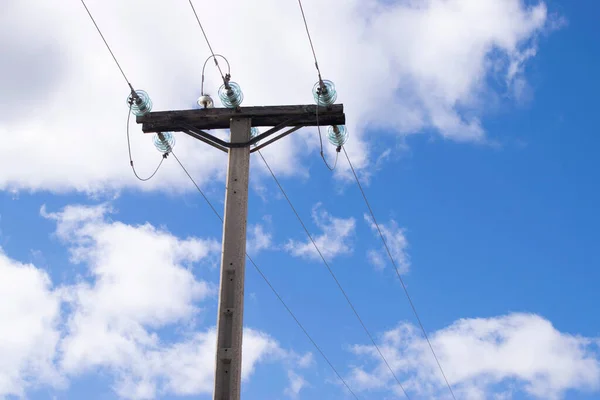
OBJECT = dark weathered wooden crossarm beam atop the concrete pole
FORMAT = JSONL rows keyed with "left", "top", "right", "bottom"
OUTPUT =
{"left": 136, "top": 104, "right": 346, "bottom": 133}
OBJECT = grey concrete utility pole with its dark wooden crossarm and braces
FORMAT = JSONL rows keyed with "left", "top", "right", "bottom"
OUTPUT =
{"left": 136, "top": 104, "right": 346, "bottom": 400}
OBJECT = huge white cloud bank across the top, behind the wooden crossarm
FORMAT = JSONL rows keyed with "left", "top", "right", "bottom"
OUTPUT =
{"left": 0, "top": 0, "right": 551, "bottom": 191}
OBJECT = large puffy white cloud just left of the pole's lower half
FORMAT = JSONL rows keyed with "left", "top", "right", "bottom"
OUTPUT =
{"left": 42, "top": 206, "right": 219, "bottom": 398}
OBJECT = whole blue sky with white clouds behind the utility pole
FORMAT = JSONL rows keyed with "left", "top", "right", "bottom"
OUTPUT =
{"left": 0, "top": 0, "right": 600, "bottom": 400}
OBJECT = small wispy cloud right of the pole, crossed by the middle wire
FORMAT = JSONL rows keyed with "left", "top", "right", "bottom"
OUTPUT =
{"left": 285, "top": 204, "right": 356, "bottom": 261}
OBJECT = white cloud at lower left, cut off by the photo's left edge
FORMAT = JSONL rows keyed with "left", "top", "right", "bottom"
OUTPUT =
{"left": 0, "top": 249, "right": 63, "bottom": 398}
